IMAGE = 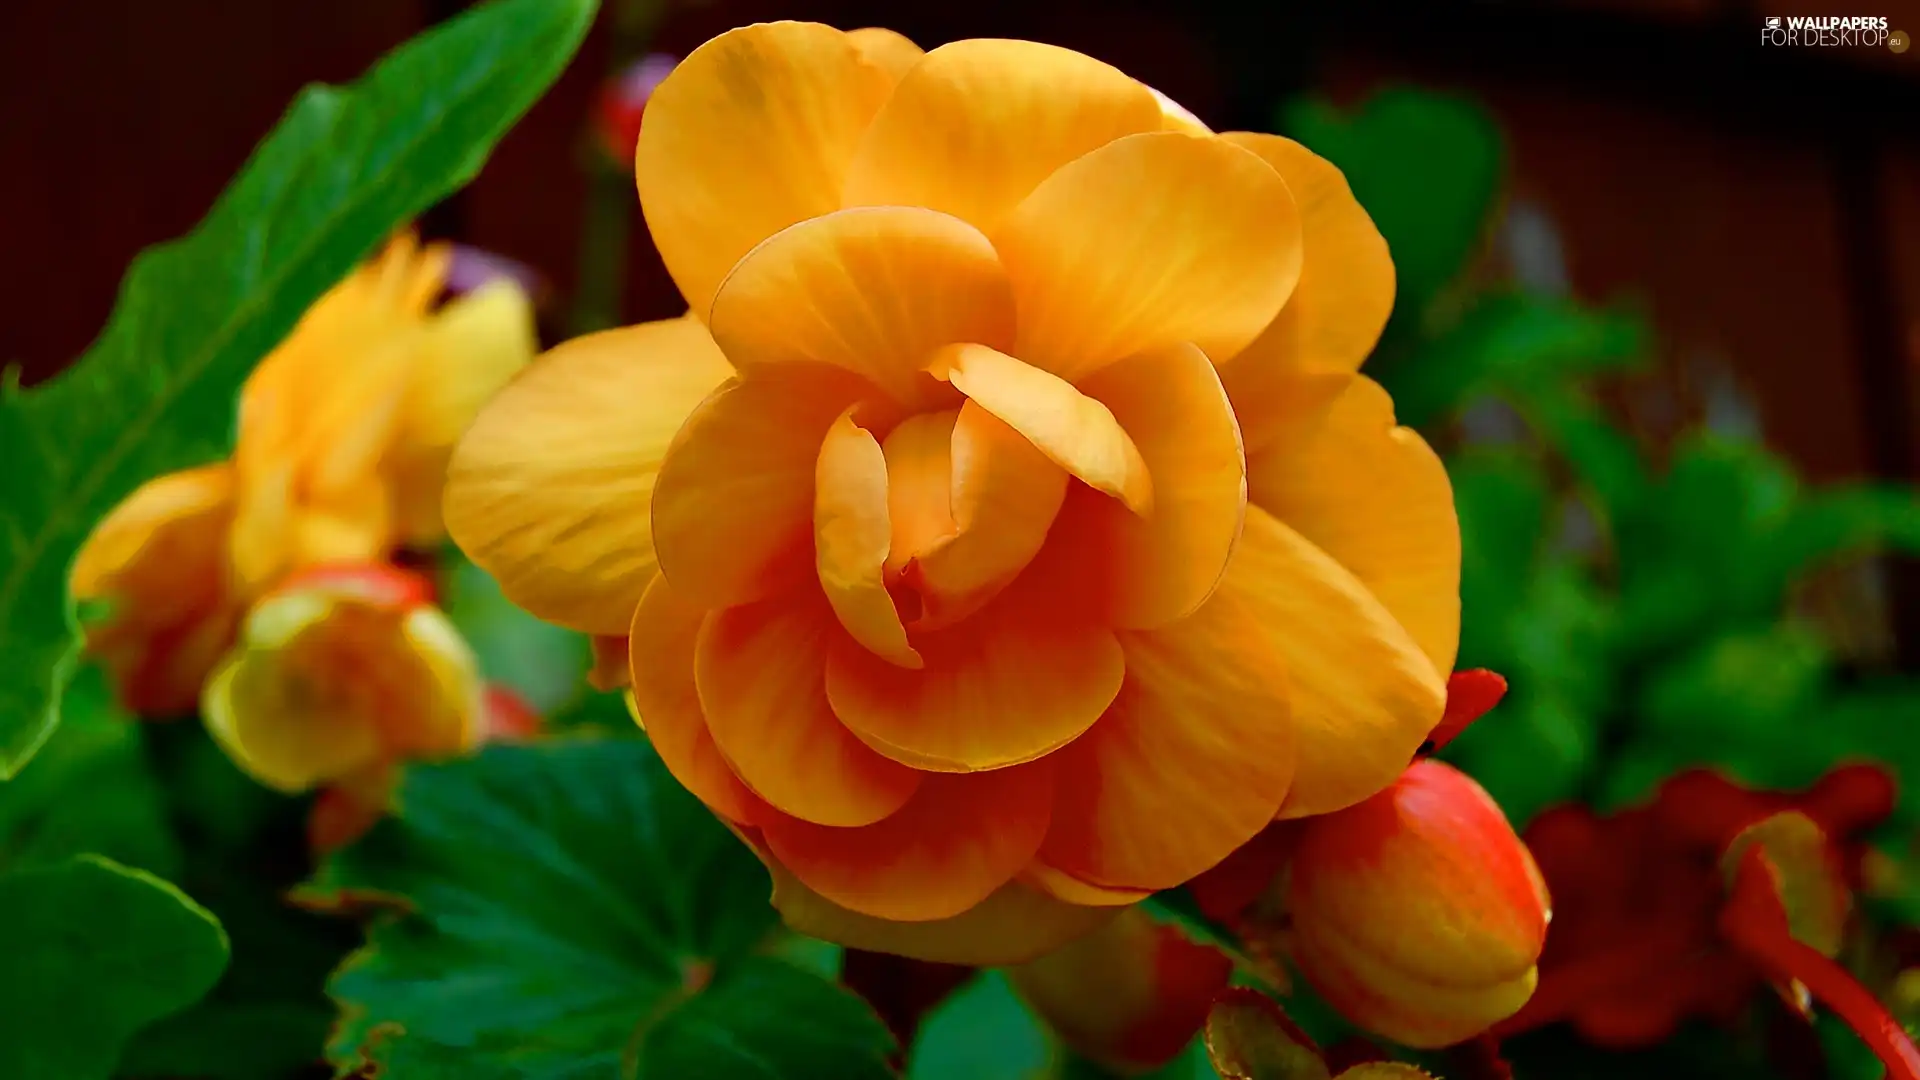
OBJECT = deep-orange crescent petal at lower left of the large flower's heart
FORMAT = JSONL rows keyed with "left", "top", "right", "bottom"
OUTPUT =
{"left": 693, "top": 598, "right": 920, "bottom": 826}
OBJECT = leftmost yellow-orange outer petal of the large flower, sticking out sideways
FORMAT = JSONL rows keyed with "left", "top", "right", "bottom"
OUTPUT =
{"left": 445, "top": 317, "right": 728, "bottom": 634}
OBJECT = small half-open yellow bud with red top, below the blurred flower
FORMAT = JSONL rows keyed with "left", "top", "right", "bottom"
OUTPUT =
{"left": 202, "top": 565, "right": 482, "bottom": 792}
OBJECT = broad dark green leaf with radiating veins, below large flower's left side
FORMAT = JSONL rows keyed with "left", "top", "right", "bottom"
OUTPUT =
{"left": 301, "top": 738, "right": 893, "bottom": 1080}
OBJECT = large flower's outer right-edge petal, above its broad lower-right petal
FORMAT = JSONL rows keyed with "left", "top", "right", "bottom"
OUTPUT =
{"left": 1248, "top": 377, "right": 1461, "bottom": 673}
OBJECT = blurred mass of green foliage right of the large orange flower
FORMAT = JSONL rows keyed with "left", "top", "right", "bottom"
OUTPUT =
{"left": 1281, "top": 90, "right": 1920, "bottom": 1080}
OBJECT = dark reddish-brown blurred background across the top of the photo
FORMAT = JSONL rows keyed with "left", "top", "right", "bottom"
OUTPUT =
{"left": 0, "top": 0, "right": 1920, "bottom": 480}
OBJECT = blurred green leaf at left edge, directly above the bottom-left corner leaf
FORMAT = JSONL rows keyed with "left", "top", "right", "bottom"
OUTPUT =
{"left": 0, "top": 671, "right": 180, "bottom": 878}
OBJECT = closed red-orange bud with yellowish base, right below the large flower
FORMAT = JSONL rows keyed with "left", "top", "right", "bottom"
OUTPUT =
{"left": 1286, "top": 761, "right": 1549, "bottom": 1047}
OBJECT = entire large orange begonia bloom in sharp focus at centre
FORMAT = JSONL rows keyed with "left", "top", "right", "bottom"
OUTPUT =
{"left": 447, "top": 23, "right": 1459, "bottom": 963}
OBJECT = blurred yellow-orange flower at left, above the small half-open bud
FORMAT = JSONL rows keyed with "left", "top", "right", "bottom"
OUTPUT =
{"left": 71, "top": 236, "right": 536, "bottom": 715}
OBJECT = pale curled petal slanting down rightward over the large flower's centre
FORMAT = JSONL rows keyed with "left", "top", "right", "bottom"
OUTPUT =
{"left": 927, "top": 344, "right": 1154, "bottom": 515}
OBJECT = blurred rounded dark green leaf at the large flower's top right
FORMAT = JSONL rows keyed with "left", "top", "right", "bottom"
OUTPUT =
{"left": 1281, "top": 88, "right": 1505, "bottom": 323}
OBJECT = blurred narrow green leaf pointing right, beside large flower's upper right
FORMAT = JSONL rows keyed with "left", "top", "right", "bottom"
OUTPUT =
{"left": 1382, "top": 292, "right": 1649, "bottom": 427}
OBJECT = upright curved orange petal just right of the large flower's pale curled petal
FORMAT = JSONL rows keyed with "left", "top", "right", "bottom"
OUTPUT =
{"left": 1081, "top": 344, "right": 1246, "bottom": 628}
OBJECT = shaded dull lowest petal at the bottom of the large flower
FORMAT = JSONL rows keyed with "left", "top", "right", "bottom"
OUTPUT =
{"left": 760, "top": 851, "right": 1119, "bottom": 965}
